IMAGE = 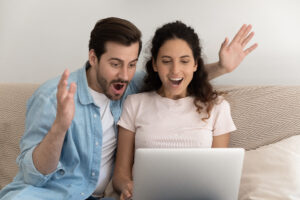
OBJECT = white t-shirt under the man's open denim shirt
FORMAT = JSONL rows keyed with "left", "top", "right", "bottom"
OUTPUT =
{"left": 90, "top": 88, "right": 117, "bottom": 195}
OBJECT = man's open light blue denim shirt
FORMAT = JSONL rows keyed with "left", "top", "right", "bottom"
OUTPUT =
{"left": 0, "top": 67, "right": 144, "bottom": 200}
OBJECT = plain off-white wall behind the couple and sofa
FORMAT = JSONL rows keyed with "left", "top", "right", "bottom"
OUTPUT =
{"left": 0, "top": 0, "right": 300, "bottom": 85}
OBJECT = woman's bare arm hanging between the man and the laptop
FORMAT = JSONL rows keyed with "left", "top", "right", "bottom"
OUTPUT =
{"left": 112, "top": 126, "right": 135, "bottom": 200}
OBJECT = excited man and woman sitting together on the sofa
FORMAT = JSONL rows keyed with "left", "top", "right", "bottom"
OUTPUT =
{"left": 0, "top": 18, "right": 257, "bottom": 200}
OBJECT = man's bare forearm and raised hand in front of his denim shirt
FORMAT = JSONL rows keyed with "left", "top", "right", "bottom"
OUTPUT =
{"left": 32, "top": 70, "right": 76, "bottom": 175}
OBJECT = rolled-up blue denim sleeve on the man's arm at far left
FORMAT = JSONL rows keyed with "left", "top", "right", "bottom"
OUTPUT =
{"left": 17, "top": 90, "right": 62, "bottom": 186}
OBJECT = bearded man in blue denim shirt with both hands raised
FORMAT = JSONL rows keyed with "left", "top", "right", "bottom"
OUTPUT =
{"left": 0, "top": 18, "right": 257, "bottom": 200}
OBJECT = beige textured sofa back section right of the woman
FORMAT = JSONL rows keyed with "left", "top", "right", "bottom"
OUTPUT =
{"left": 219, "top": 86, "right": 300, "bottom": 150}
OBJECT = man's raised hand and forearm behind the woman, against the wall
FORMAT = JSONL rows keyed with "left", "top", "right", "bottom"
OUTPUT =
{"left": 205, "top": 24, "right": 258, "bottom": 80}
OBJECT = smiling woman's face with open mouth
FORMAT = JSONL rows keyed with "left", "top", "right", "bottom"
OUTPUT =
{"left": 153, "top": 39, "right": 197, "bottom": 99}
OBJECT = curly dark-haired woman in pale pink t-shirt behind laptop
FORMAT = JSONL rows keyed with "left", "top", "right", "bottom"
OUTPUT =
{"left": 113, "top": 21, "right": 236, "bottom": 199}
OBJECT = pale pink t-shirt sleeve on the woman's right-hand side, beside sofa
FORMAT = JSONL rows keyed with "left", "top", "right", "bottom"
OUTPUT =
{"left": 213, "top": 100, "right": 236, "bottom": 136}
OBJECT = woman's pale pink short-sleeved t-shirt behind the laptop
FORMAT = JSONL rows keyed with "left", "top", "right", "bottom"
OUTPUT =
{"left": 118, "top": 92, "right": 236, "bottom": 149}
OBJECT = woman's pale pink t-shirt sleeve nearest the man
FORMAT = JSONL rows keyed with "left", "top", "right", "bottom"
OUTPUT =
{"left": 118, "top": 95, "right": 136, "bottom": 132}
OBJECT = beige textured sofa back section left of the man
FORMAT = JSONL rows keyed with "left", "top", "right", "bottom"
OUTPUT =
{"left": 0, "top": 84, "right": 38, "bottom": 189}
